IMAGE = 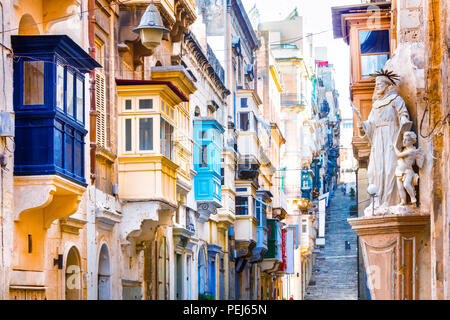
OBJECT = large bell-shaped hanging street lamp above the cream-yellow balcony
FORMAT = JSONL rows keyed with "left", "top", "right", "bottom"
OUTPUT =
{"left": 133, "top": 4, "right": 169, "bottom": 52}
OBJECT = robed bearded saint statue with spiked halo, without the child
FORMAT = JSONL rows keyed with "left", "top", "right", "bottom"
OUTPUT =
{"left": 354, "top": 69, "right": 412, "bottom": 215}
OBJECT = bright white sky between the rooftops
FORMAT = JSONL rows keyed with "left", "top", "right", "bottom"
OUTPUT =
{"left": 242, "top": 0, "right": 361, "bottom": 118}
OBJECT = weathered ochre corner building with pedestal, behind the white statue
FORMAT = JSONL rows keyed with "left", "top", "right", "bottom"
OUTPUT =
{"left": 332, "top": 0, "right": 449, "bottom": 300}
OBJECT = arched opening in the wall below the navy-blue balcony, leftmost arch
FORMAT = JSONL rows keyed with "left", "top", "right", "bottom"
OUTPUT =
{"left": 65, "top": 247, "right": 82, "bottom": 300}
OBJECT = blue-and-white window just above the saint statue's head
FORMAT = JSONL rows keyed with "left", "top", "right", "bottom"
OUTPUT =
{"left": 359, "top": 30, "right": 390, "bottom": 78}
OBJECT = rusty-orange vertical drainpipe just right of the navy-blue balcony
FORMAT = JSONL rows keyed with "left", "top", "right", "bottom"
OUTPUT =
{"left": 88, "top": 0, "right": 97, "bottom": 184}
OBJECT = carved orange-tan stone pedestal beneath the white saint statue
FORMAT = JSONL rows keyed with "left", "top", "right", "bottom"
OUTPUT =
{"left": 348, "top": 214, "right": 430, "bottom": 300}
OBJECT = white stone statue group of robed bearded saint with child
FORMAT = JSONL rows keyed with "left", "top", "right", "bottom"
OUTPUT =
{"left": 354, "top": 69, "right": 424, "bottom": 216}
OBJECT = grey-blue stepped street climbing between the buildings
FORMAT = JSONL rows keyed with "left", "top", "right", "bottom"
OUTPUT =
{"left": 305, "top": 188, "right": 358, "bottom": 300}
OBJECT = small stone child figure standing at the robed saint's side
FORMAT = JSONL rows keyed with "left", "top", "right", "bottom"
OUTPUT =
{"left": 394, "top": 131, "right": 424, "bottom": 205}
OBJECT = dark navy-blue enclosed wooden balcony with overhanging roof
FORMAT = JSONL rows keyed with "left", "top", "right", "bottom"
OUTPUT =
{"left": 11, "top": 35, "right": 101, "bottom": 185}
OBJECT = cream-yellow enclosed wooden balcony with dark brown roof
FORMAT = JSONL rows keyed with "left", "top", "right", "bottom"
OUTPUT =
{"left": 116, "top": 80, "right": 188, "bottom": 207}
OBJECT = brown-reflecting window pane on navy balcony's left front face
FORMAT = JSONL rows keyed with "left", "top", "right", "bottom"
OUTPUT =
{"left": 23, "top": 61, "right": 44, "bottom": 105}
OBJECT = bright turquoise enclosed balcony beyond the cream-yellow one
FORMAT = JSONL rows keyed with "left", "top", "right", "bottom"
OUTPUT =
{"left": 194, "top": 119, "right": 225, "bottom": 219}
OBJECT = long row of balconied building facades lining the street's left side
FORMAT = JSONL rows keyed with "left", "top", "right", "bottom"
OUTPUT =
{"left": 0, "top": 0, "right": 339, "bottom": 300}
